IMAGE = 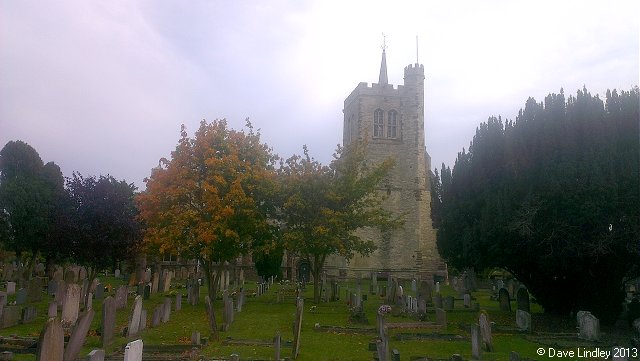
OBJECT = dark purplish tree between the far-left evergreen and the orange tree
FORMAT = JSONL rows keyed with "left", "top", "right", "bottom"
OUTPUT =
{"left": 67, "top": 173, "right": 142, "bottom": 279}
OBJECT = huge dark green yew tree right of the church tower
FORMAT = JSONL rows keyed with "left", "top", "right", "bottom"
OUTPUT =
{"left": 432, "top": 87, "right": 640, "bottom": 322}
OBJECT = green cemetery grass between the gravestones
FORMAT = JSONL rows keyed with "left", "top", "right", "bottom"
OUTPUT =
{"left": 0, "top": 277, "right": 632, "bottom": 361}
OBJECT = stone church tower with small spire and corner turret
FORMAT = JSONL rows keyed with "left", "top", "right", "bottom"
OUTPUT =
{"left": 327, "top": 47, "right": 446, "bottom": 279}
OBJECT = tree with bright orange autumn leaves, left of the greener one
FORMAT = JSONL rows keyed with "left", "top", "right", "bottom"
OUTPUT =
{"left": 138, "top": 120, "right": 276, "bottom": 338}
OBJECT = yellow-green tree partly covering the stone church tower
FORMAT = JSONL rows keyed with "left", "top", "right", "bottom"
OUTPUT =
{"left": 279, "top": 142, "right": 401, "bottom": 303}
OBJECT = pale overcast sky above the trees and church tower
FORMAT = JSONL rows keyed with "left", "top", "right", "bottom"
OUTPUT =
{"left": 0, "top": 0, "right": 640, "bottom": 189}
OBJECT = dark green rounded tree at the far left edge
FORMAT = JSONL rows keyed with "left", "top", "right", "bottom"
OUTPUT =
{"left": 0, "top": 140, "right": 66, "bottom": 268}
